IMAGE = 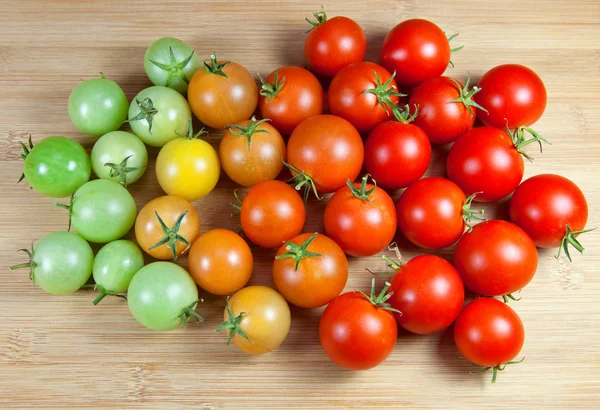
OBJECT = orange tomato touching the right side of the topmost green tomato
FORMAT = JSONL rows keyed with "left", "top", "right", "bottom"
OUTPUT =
{"left": 188, "top": 54, "right": 258, "bottom": 128}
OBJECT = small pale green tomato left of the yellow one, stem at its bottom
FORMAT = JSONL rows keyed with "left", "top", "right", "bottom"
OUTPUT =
{"left": 91, "top": 131, "right": 148, "bottom": 186}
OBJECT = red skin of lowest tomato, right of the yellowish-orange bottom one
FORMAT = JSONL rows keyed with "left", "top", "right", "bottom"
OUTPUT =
{"left": 319, "top": 292, "right": 398, "bottom": 370}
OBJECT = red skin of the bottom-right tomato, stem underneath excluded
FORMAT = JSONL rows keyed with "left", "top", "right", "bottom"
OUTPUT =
{"left": 454, "top": 298, "right": 525, "bottom": 367}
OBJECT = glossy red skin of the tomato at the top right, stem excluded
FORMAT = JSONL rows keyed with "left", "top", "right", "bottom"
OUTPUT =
{"left": 381, "top": 19, "right": 450, "bottom": 87}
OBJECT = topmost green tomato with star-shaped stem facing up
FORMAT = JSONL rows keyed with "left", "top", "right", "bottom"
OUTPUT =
{"left": 144, "top": 37, "right": 202, "bottom": 94}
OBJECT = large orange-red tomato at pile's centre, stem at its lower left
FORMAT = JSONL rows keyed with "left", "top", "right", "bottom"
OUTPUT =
{"left": 287, "top": 115, "right": 364, "bottom": 199}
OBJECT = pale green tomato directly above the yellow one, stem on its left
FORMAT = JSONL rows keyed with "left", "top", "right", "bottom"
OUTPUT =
{"left": 129, "top": 85, "right": 192, "bottom": 147}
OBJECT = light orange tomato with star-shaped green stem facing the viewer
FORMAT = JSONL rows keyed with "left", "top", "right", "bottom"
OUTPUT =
{"left": 135, "top": 195, "right": 200, "bottom": 260}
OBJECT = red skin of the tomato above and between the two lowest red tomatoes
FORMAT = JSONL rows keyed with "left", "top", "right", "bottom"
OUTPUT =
{"left": 388, "top": 255, "right": 465, "bottom": 335}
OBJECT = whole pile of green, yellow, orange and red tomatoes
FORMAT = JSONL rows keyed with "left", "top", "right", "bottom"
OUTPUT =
{"left": 11, "top": 12, "right": 589, "bottom": 381}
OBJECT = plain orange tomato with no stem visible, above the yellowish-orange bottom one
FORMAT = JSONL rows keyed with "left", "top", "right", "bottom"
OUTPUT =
{"left": 188, "top": 229, "right": 253, "bottom": 295}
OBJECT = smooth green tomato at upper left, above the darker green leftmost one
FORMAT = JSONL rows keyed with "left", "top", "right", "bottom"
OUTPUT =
{"left": 68, "top": 73, "right": 129, "bottom": 137}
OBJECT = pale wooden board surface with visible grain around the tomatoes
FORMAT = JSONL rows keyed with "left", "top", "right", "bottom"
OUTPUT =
{"left": 0, "top": 0, "right": 600, "bottom": 409}
